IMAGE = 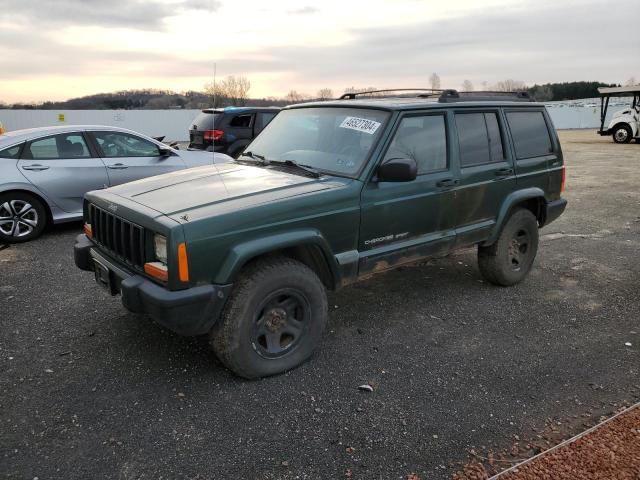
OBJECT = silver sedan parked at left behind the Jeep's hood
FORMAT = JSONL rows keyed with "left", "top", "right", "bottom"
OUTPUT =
{"left": 0, "top": 125, "right": 233, "bottom": 244}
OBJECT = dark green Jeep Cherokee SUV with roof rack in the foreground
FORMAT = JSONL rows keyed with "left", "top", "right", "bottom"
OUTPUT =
{"left": 75, "top": 90, "right": 566, "bottom": 378}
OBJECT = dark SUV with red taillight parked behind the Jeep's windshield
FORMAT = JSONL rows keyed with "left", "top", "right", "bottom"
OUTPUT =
{"left": 189, "top": 107, "right": 280, "bottom": 158}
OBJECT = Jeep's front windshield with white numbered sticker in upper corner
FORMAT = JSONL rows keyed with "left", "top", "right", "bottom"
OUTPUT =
{"left": 245, "top": 107, "right": 389, "bottom": 177}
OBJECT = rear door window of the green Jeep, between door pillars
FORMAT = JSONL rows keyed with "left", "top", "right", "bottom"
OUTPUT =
{"left": 456, "top": 112, "right": 504, "bottom": 167}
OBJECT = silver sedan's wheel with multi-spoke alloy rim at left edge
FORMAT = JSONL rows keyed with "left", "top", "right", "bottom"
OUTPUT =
{"left": 0, "top": 192, "right": 47, "bottom": 243}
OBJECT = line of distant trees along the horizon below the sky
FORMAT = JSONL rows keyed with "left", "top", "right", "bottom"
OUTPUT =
{"left": 0, "top": 72, "right": 636, "bottom": 110}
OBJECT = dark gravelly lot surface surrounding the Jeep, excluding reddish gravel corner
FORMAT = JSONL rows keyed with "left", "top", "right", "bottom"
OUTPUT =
{"left": 0, "top": 130, "right": 640, "bottom": 480}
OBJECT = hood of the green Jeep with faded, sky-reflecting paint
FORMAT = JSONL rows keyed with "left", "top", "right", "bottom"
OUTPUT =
{"left": 107, "top": 162, "right": 344, "bottom": 216}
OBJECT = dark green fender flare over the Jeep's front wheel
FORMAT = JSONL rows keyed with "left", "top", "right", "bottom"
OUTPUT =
{"left": 214, "top": 229, "right": 339, "bottom": 285}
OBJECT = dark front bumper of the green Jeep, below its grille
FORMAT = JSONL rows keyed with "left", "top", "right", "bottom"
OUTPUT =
{"left": 74, "top": 234, "right": 232, "bottom": 335}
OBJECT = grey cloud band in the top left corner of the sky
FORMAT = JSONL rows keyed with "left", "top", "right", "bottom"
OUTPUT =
{"left": 0, "top": 0, "right": 220, "bottom": 30}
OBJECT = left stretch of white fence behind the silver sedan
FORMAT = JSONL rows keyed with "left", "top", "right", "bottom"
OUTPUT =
{"left": 0, "top": 110, "right": 200, "bottom": 141}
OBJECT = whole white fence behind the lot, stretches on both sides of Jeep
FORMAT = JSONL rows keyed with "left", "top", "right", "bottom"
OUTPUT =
{"left": 0, "top": 102, "right": 624, "bottom": 142}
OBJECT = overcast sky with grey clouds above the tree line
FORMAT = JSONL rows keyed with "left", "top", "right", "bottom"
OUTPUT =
{"left": 0, "top": 0, "right": 640, "bottom": 102}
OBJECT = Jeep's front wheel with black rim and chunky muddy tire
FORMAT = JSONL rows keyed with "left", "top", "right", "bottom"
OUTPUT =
{"left": 210, "top": 256, "right": 327, "bottom": 378}
